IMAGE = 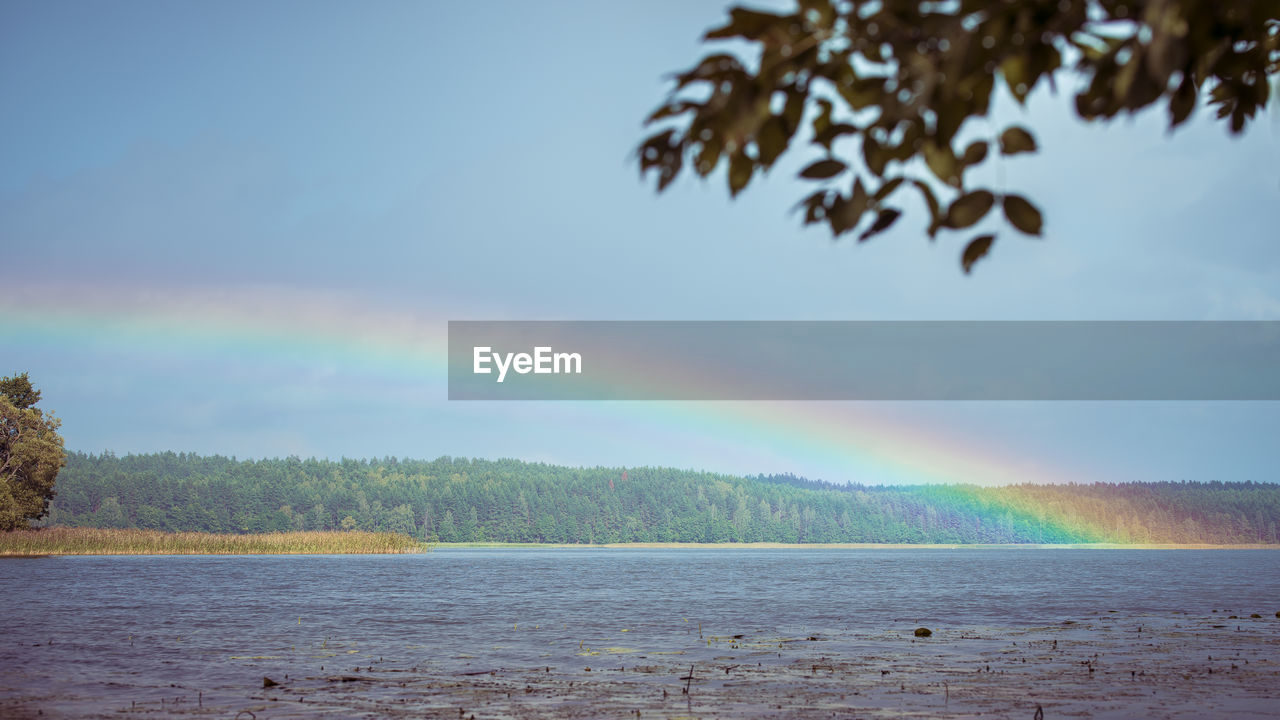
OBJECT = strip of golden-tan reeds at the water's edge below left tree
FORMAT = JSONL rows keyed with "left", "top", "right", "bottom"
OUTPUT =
{"left": 0, "top": 528, "right": 431, "bottom": 556}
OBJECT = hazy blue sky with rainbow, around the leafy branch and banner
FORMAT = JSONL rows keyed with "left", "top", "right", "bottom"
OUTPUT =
{"left": 0, "top": 0, "right": 1280, "bottom": 484}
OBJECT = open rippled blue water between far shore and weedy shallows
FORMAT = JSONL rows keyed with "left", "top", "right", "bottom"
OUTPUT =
{"left": 0, "top": 548, "right": 1280, "bottom": 714}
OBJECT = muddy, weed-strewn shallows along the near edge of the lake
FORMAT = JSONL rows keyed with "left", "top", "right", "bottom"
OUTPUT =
{"left": 0, "top": 611, "right": 1280, "bottom": 720}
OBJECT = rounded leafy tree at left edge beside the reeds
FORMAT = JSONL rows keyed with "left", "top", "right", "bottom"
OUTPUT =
{"left": 0, "top": 373, "right": 67, "bottom": 530}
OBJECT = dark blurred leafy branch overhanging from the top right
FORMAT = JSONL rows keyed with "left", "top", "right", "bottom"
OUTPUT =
{"left": 637, "top": 0, "right": 1280, "bottom": 272}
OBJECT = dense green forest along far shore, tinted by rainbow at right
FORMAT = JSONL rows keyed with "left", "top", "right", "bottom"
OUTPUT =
{"left": 46, "top": 452, "right": 1280, "bottom": 543}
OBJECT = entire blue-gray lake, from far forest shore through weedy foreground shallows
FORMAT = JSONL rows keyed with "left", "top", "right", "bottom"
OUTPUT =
{"left": 0, "top": 548, "right": 1280, "bottom": 717}
